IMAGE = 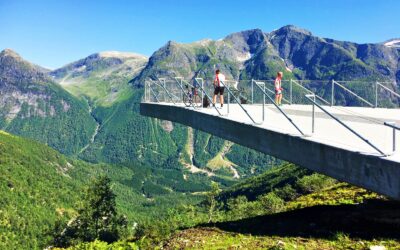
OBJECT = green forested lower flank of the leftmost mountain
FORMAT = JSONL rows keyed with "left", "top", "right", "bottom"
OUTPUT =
{"left": 2, "top": 84, "right": 95, "bottom": 155}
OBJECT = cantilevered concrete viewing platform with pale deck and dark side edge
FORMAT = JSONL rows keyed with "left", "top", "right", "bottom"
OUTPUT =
{"left": 140, "top": 102, "right": 400, "bottom": 200}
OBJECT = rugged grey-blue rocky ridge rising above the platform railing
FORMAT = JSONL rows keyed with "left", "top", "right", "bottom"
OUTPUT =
{"left": 131, "top": 25, "right": 400, "bottom": 106}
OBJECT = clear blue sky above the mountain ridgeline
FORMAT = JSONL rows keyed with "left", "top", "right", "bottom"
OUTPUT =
{"left": 0, "top": 0, "right": 400, "bottom": 68}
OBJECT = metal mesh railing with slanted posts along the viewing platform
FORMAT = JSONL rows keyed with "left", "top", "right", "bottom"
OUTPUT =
{"left": 143, "top": 77, "right": 400, "bottom": 155}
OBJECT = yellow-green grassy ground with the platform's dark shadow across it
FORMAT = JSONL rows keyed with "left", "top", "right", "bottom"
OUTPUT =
{"left": 164, "top": 183, "right": 400, "bottom": 249}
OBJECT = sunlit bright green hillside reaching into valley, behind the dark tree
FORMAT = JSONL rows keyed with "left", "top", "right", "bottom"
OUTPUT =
{"left": 0, "top": 131, "right": 209, "bottom": 249}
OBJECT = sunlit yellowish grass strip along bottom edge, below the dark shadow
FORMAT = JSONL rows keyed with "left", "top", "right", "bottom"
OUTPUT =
{"left": 163, "top": 227, "right": 400, "bottom": 250}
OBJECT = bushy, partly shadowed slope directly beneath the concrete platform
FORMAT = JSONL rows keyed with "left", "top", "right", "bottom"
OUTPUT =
{"left": 162, "top": 164, "right": 400, "bottom": 249}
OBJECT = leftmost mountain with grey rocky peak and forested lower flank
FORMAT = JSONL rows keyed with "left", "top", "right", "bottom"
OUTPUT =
{"left": 0, "top": 49, "right": 95, "bottom": 154}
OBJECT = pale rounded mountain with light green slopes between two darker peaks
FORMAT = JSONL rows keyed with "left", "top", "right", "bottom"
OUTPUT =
{"left": 50, "top": 51, "right": 148, "bottom": 106}
